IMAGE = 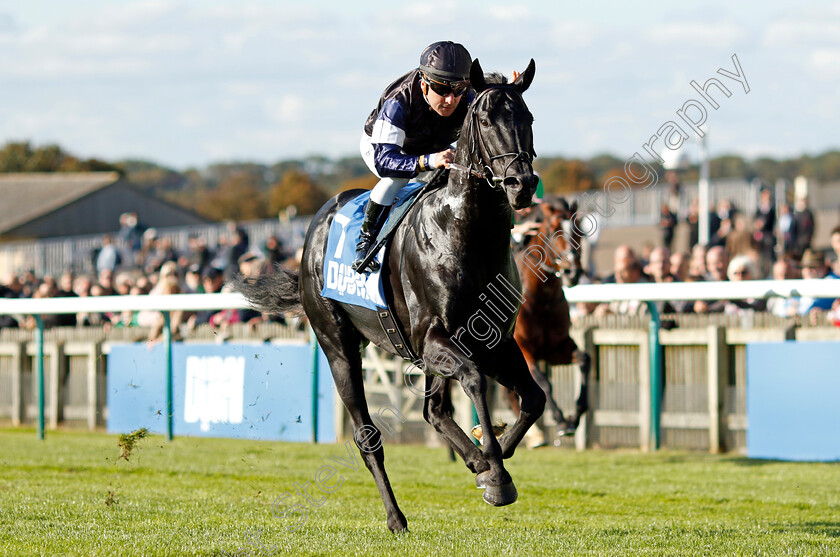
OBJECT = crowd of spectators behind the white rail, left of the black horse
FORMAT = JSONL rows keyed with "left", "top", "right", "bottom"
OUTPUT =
{"left": 0, "top": 213, "right": 297, "bottom": 341}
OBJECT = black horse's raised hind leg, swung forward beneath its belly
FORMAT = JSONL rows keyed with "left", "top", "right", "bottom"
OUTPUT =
{"left": 423, "top": 375, "right": 490, "bottom": 474}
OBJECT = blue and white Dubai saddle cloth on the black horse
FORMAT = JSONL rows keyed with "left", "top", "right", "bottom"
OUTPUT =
{"left": 321, "top": 182, "right": 425, "bottom": 310}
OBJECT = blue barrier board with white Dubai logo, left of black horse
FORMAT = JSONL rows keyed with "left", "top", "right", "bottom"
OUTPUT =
{"left": 107, "top": 343, "right": 336, "bottom": 443}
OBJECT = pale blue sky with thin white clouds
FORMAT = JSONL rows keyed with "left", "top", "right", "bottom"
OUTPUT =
{"left": 0, "top": 0, "right": 840, "bottom": 169}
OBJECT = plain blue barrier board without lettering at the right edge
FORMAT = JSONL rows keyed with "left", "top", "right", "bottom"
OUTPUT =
{"left": 747, "top": 341, "right": 840, "bottom": 461}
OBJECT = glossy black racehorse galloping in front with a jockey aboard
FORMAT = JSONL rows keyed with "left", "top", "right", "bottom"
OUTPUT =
{"left": 239, "top": 60, "right": 545, "bottom": 532}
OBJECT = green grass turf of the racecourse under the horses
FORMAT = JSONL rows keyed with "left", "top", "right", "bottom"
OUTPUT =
{"left": 0, "top": 429, "right": 840, "bottom": 557}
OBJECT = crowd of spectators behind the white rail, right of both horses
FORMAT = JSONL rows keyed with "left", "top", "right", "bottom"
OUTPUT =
{"left": 573, "top": 210, "right": 840, "bottom": 326}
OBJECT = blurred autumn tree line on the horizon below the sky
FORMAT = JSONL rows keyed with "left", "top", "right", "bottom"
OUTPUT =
{"left": 0, "top": 141, "right": 840, "bottom": 220}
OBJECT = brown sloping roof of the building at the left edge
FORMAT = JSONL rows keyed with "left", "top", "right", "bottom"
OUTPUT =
{"left": 0, "top": 172, "right": 120, "bottom": 234}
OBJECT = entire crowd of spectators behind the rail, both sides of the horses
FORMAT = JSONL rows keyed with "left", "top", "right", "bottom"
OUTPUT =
{"left": 6, "top": 190, "right": 840, "bottom": 332}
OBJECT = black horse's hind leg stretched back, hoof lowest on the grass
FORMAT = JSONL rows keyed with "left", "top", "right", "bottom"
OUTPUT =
{"left": 312, "top": 322, "right": 408, "bottom": 532}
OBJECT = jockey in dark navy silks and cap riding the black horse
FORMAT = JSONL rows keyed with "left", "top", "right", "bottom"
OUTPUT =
{"left": 353, "top": 41, "right": 473, "bottom": 273}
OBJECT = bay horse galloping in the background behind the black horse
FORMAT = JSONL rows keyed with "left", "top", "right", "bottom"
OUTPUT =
{"left": 508, "top": 196, "right": 591, "bottom": 444}
